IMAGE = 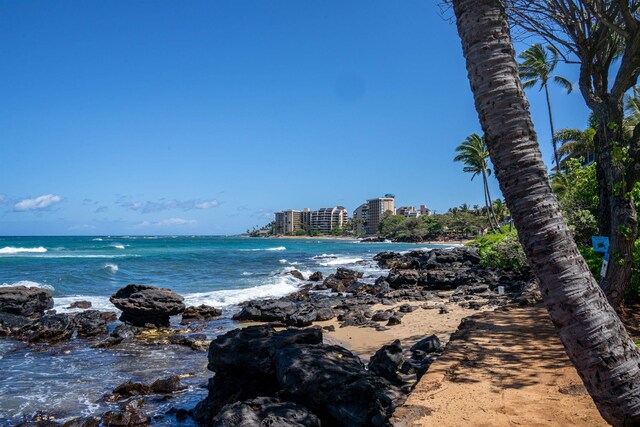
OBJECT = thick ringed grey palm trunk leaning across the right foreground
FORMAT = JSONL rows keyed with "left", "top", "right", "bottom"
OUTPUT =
{"left": 453, "top": 0, "right": 640, "bottom": 426}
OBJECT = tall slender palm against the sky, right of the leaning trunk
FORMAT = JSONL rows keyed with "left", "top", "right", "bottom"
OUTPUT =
{"left": 518, "top": 43, "right": 573, "bottom": 166}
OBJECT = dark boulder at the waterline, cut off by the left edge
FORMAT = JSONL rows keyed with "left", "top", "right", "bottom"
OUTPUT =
{"left": 0, "top": 286, "right": 53, "bottom": 316}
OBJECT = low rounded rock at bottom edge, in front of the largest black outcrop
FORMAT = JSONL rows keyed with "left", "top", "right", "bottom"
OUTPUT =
{"left": 212, "top": 397, "right": 320, "bottom": 427}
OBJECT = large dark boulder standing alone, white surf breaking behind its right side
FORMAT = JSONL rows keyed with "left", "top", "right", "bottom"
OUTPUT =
{"left": 109, "top": 285, "right": 185, "bottom": 326}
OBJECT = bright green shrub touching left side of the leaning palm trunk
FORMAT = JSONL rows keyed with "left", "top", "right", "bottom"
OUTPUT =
{"left": 473, "top": 230, "right": 527, "bottom": 271}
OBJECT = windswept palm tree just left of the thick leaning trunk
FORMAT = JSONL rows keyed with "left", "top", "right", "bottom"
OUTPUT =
{"left": 453, "top": 133, "right": 499, "bottom": 231}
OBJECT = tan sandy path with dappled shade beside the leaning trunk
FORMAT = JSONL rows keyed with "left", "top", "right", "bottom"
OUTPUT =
{"left": 394, "top": 307, "right": 607, "bottom": 427}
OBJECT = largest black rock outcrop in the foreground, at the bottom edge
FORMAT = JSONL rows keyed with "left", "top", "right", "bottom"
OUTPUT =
{"left": 194, "top": 325, "right": 404, "bottom": 426}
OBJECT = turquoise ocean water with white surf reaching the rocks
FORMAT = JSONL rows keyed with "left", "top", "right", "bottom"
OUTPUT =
{"left": 0, "top": 236, "right": 450, "bottom": 425}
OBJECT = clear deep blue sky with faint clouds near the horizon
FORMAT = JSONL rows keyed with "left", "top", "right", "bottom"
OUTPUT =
{"left": 0, "top": 0, "right": 587, "bottom": 235}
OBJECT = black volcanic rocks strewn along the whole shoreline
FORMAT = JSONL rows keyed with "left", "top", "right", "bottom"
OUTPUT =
{"left": 0, "top": 247, "right": 537, "bottom": 426}
